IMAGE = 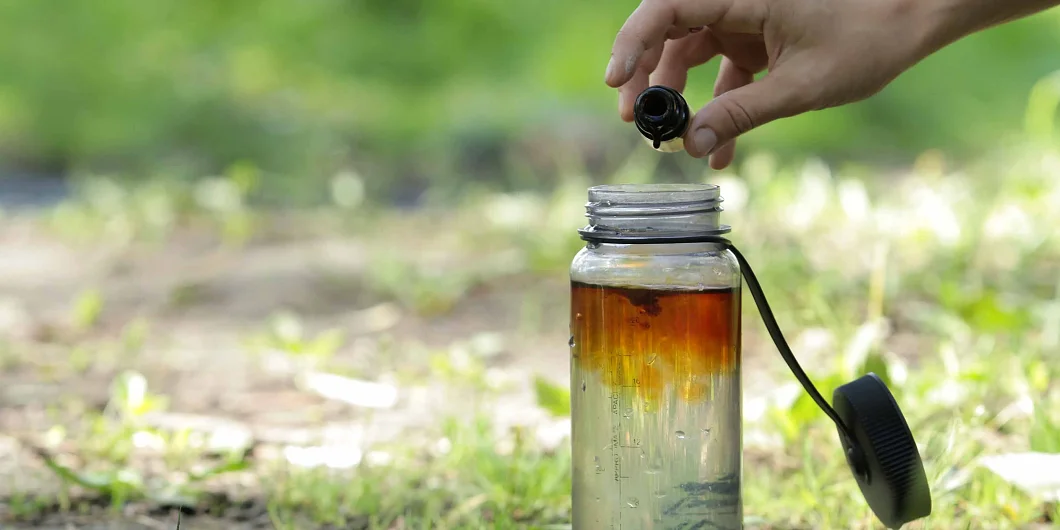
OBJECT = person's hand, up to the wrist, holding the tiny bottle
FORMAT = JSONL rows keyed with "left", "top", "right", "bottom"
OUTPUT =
{"left": 605, "top": 0, "right": 949, "bottom": 170}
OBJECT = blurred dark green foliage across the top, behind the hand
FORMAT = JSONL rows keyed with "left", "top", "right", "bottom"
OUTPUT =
{"left": 0, "top": 0, "right": 1060, "bottom": 202}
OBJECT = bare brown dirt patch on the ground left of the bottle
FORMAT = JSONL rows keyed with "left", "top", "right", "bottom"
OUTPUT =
{"left": 0, "top": 213, "right": 779, "bottom": 530}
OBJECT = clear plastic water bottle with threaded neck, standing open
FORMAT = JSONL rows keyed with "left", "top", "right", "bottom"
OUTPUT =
{"left": 570, "top": 184, "right": 743, "bottom": 530}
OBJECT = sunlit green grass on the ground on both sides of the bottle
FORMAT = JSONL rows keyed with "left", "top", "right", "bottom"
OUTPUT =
{"left": 2, "top": 113, "right": 1060, "bottom": 530}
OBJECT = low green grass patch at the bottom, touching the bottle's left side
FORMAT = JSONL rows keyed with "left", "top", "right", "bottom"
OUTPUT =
{"left": 261, "top": 418, "right": 570, "bottom": 528}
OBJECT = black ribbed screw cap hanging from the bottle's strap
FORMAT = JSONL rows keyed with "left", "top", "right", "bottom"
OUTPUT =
{"left": 832, "top": 373, "right": 932, "bottom": 529}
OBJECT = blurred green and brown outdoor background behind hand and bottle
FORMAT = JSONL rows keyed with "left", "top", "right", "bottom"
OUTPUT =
{"left": 0, "top": 0, "right": 1060, "bottom": 530}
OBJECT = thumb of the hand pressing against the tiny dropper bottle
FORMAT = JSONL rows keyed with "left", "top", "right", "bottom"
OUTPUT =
{"left": 685, "top": 71, "right": 812, "bottom": 158}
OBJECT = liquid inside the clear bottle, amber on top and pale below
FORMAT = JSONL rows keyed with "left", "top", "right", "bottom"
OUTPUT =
{"left": 570, "top": 282, "right": 743, "bottom": 530}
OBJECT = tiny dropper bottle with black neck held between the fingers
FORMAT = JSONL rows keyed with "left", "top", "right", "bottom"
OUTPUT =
{"left": 633, "top": 85, "right": 692, "bottom": 153}
